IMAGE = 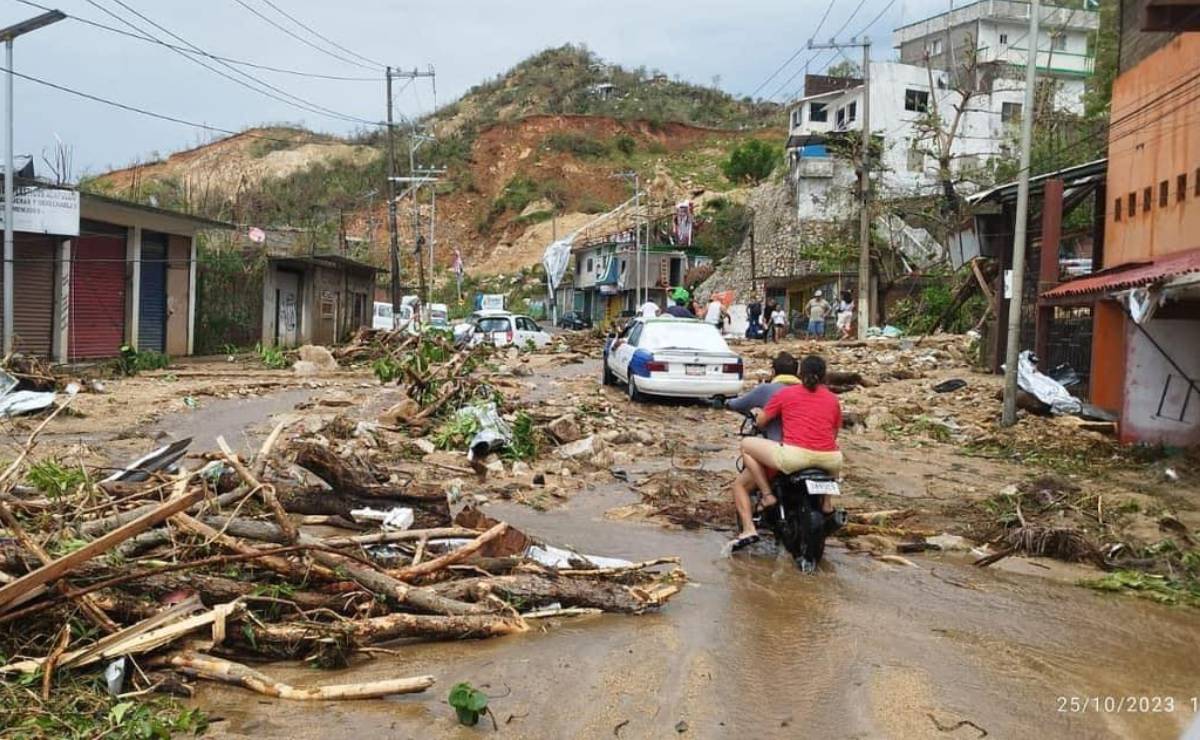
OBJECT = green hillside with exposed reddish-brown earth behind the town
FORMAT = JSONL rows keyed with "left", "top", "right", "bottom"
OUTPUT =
{"left": 86, "top": 47, "right": 785, "bottom": 273}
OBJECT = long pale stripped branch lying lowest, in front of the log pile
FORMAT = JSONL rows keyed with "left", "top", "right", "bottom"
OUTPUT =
{"left": 154, "top": 650, "right": 434, "bottom": 702}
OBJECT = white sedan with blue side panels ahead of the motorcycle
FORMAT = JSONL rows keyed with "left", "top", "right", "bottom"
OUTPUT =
{"left": 601, "top": 318, "right": 743, "bottom": 401}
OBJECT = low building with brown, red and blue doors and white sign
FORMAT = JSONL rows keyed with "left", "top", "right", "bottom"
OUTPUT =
{"left": 1, "top": 181, "right": 230, "bottom": 362}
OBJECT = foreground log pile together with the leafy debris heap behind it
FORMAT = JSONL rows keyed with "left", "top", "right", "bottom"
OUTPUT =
{"left": 0, "top": 333, "right": 684, "bottom": 714}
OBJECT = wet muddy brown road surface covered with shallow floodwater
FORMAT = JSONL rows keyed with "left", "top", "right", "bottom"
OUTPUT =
{"left": 194, "top": 361, "right": 1200, "bottom": 738}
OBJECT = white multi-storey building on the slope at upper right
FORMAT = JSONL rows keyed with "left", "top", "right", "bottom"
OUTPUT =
{"left": 787, "top": 0, "right": 1098, "bottom": 219}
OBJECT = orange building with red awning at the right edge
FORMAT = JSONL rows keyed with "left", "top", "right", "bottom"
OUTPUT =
{"left": 1042, "top": 21, "right": 1200, "bottom": 446}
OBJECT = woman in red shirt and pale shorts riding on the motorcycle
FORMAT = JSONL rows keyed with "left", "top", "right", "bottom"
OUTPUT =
{"left": 742, "top": 355, "right": 842, "bottom": 513}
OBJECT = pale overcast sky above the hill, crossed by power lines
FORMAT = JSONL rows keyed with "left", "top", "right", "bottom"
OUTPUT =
{"left": 0, "top": 0, "right": 964, "bottom": 176}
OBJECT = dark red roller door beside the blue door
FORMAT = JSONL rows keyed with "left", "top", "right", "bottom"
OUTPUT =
{"left": 68, "top": 224, "right": 125, "bottom": 360}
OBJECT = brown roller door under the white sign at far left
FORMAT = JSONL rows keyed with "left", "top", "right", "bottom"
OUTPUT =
{"left": 0, "top": 234, "right": 58, "bottom": 357}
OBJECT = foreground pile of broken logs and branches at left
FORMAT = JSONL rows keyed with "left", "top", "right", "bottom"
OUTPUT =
{"left": 0, "top": 402, "right": 683, "bottom": 699}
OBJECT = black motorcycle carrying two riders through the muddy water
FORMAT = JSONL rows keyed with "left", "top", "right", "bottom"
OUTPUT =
{"left": 737, "top": 415, "right": 847, "bottom": 573}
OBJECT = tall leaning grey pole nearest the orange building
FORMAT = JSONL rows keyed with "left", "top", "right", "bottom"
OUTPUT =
{"left": 1000, "top": 0, "right": 1042, "bottom": 427}
